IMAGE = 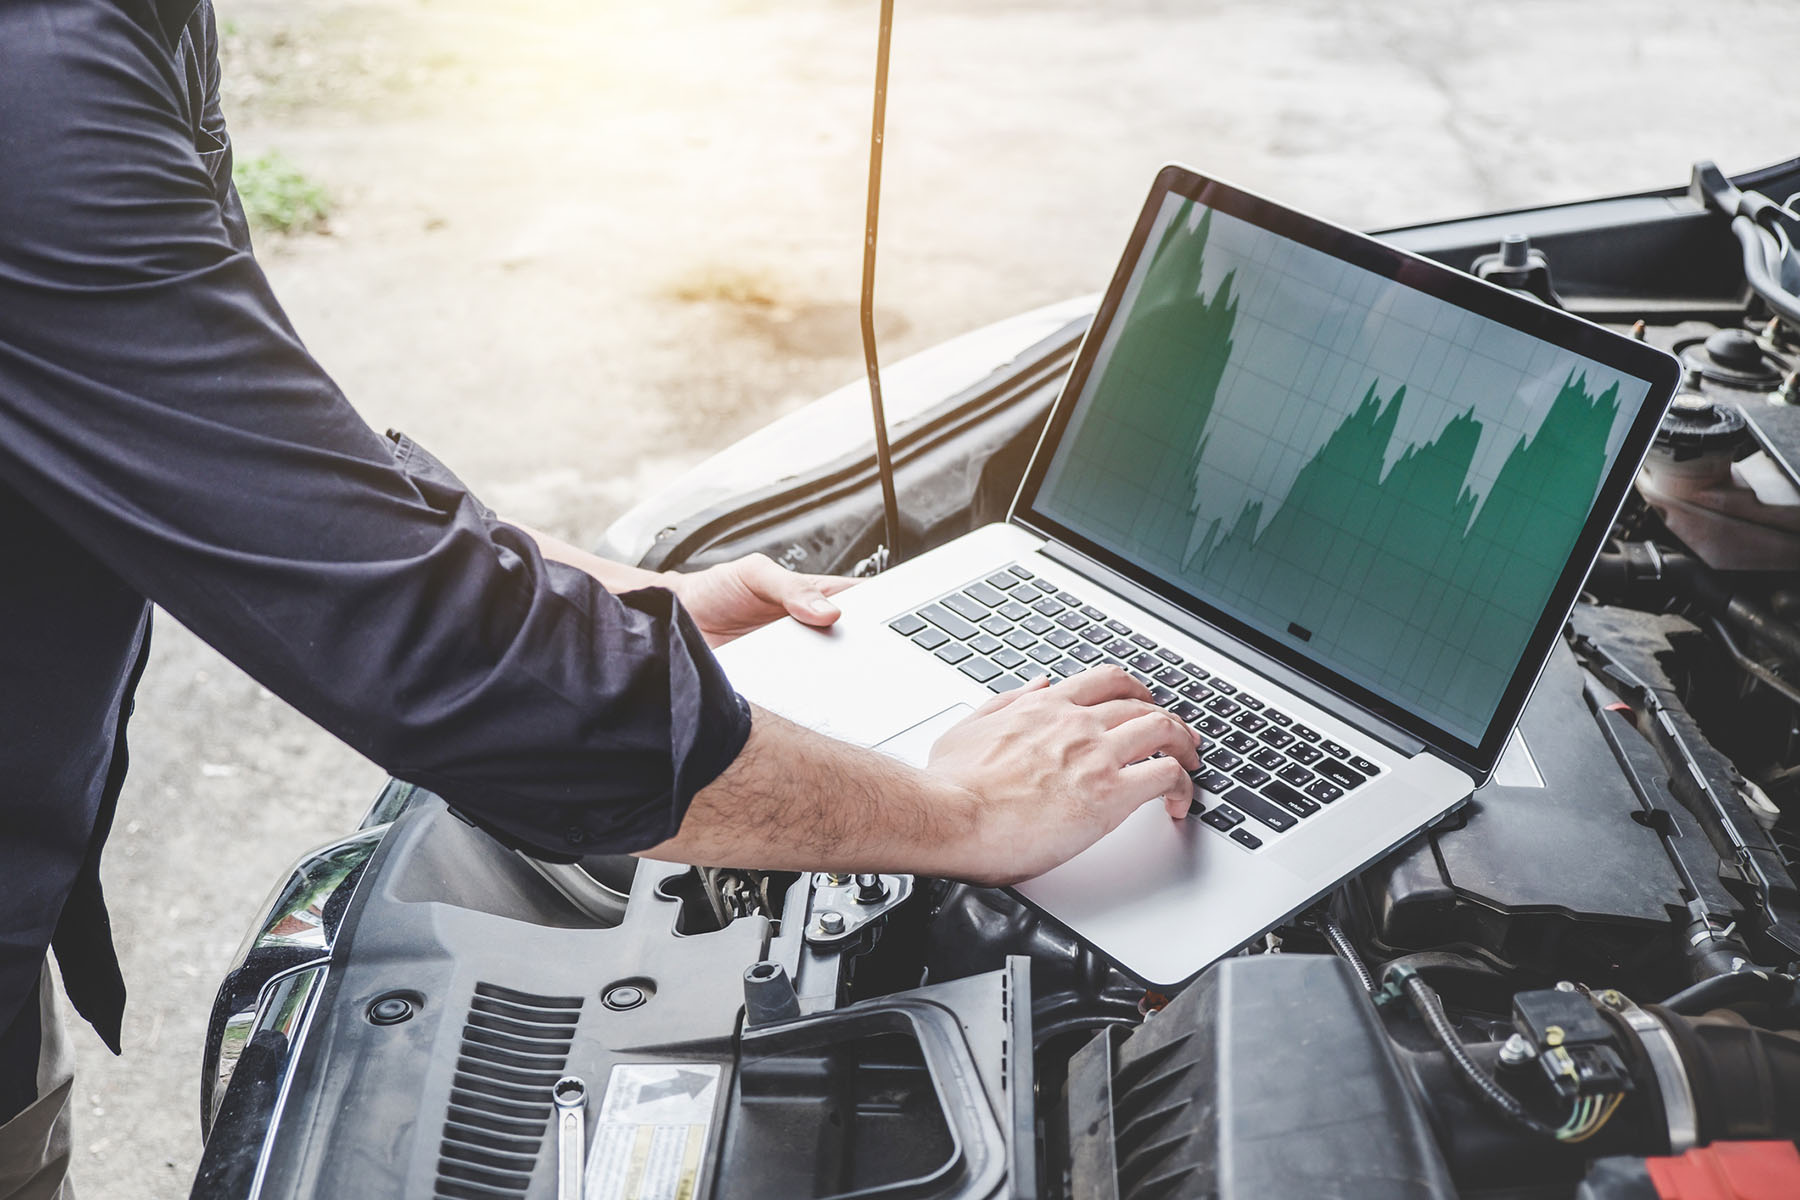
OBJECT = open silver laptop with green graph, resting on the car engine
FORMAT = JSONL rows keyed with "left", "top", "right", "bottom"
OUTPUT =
{"left": 720, "top": 166, "right": 1679, "bottom": 986}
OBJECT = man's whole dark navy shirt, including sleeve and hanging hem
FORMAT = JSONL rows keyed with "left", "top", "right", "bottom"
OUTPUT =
{"left": 0, "top": 0, "right": 749, "bottom": 1049}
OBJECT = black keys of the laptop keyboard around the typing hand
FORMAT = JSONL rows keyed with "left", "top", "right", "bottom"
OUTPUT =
{"left": 887, "top": 565, "right": 1386, "bottom": 849}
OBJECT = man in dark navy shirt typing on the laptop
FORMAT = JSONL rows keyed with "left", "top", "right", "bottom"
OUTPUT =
{"left": 0, "top": 0, "right": 1197, "bottom": 1198}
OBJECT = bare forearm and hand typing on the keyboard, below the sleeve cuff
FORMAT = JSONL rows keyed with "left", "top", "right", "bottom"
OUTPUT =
{"left": 641, "top": 667, "right": 1199, "bottom": 883}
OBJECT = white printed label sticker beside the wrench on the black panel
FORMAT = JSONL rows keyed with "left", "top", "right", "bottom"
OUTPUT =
{"left": 583, "top": 1063, "right": 720, "bottom": 1200}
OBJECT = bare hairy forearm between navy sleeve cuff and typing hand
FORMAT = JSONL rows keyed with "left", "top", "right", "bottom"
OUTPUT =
{"left": 643, "top": 709, "right": 983, "bottom": 878}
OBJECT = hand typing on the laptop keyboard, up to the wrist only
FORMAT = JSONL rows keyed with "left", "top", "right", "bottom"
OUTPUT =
{"left": 927, "top": 666, "right": 1201, "bottom": 883}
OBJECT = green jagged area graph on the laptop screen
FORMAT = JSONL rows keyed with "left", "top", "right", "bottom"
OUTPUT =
{"left": 1049, "top": 207, "right": 1622, "bottom": 739}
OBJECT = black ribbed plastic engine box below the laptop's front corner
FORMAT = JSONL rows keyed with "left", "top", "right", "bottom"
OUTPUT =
{"left": 1062, "top": 954, "right": 1456, "bottom": 1200}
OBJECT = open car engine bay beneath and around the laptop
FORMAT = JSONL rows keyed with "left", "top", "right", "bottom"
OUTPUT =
{"left": 194, "top": 164, "right": 1800, "bottom": 1200}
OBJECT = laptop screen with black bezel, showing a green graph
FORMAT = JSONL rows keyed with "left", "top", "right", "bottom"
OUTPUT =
{"left": 1031, "top": 170, "right": 1667, "bottom": 759}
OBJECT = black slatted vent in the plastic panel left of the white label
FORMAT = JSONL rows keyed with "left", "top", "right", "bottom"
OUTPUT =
{"left": 434, "top": 984, "right": 581, "bottom": 1200}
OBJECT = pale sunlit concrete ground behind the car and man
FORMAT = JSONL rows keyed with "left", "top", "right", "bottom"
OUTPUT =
{"left": 59, "top": 0, "right": 1800, "bottom": 1200}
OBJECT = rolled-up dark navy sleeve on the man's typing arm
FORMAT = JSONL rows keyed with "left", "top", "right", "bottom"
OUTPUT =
{"left": 0, "top": 0, "right": 749, "bottom": 855}
